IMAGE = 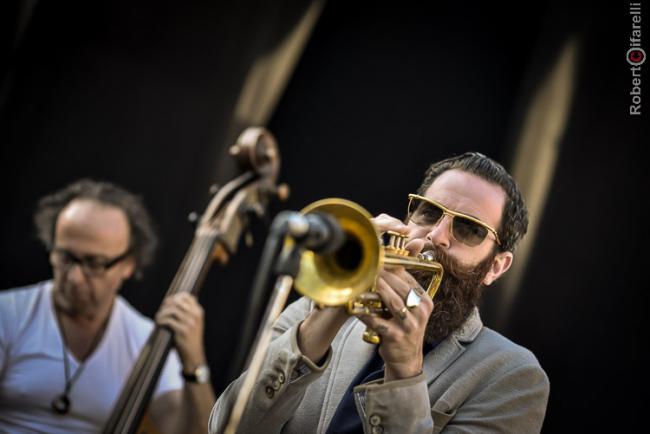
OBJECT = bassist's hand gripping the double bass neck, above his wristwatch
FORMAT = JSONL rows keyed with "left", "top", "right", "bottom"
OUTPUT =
{"left": 156, "top": 292, "right": 205, "bottom": 371}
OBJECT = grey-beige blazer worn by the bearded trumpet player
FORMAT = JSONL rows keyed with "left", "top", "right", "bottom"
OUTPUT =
{"left": 210, "top": 298, "right": 549, "bottom": 434}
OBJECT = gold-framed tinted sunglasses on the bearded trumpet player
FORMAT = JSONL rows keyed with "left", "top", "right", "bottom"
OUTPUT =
{"left": 407, "top": 194, "right": 501, "bottom": 247}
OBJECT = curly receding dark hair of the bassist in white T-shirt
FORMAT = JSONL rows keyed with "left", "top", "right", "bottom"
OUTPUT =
{"left": 34, "top": 179, "right": 158, "bottom": 278}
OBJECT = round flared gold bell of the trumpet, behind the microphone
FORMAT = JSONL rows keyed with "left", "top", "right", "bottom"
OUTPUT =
{"left": 294, "top": 198, "right": 382, "bottom": 306}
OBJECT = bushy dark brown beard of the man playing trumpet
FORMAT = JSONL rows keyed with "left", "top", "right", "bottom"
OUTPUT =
{"left": 411, "top": 244, "right": 496, "bottom": 345}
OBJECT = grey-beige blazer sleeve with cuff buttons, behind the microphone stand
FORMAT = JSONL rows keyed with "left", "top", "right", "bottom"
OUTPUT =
{"left": 209, "top": 297, "right": 332, "bottom": 434}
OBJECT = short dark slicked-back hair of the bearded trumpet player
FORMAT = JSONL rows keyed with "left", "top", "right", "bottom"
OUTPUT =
{"left": 418, "top": 152, "right": 528, "bottom": 252}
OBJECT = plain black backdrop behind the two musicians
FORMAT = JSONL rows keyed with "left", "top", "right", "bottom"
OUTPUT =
{"left": 0, "top": 0, "right": 650, "bottom": 433}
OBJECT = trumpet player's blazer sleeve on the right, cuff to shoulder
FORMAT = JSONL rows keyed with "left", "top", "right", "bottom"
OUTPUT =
{"left": 354, "top": 354, "right": 549, "bottom": 434}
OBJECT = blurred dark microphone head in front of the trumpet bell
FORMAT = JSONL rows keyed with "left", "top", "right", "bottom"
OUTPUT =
{"left": 287, "top": 212, "right": 345, "bottom": 254}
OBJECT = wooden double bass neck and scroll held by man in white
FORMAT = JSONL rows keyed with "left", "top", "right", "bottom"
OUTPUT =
{"left": 104, "top": 127, "right": 288, "bottom": 434}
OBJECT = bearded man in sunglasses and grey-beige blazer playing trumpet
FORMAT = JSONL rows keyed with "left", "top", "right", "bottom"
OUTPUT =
{"left": 210, "top": 153, "right": 549, "bottom": 434}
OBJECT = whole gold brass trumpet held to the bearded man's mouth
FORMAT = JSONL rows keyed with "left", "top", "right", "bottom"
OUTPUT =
{"left": 294, "top": 198, "right": 444, "bottom": 344}
